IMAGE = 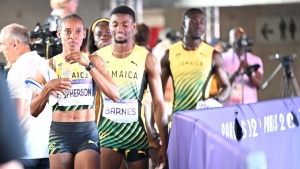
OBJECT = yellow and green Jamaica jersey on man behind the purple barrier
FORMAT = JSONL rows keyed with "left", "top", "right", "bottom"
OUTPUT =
{"left": 169, "top": 41, "right": 214, "bottom": 113}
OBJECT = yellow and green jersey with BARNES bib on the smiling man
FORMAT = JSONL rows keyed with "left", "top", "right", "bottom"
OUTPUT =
{"left": 97, "top": 45, "right": 149, "bottom": 150}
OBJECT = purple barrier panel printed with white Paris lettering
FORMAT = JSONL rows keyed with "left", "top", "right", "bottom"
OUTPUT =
{"left": 170, "top": 97, "right": 300, "bottom": 169}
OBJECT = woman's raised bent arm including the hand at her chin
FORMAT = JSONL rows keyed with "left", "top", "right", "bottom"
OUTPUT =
{"left": 65, "top": 52, "right": 119, "bottom": 101}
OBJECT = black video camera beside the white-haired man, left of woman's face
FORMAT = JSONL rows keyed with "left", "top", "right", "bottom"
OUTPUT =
{"left": 29, "top": 23, "right": 62, "bottom": 59}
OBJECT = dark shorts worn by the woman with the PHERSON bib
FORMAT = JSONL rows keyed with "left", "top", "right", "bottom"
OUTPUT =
{"left": 48, "top": 121, "right": 100, "bottom": 155}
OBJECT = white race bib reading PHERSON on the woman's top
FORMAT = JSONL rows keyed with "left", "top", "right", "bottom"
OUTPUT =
{"left": 58, "top": 79, "right": 94, "bottom": 106}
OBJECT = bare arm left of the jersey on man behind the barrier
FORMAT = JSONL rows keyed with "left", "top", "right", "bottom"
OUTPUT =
{"left": 160, "top": 50, "right": 171, "bottom": 93}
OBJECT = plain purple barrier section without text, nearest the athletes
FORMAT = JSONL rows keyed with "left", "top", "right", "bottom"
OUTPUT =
{"left": 168, "top": 114, "right": 249, "bottom": 169}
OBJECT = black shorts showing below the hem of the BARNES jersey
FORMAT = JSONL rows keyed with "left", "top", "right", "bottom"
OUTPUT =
{"left": 112, "top": 148, "right": 149, "bottom": 162}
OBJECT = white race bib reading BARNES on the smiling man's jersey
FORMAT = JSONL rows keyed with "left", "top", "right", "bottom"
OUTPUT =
{"left": 102, "top": 99, "right": 138, "bottom": 123}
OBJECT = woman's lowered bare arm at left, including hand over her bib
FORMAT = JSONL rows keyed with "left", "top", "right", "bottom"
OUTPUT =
{"left": 30, "top": 59, "right": 72, "bottom": 117}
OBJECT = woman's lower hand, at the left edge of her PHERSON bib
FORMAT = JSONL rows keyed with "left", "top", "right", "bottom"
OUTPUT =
{"left": 44, "top": 78, "right": 72, "bottom": 95}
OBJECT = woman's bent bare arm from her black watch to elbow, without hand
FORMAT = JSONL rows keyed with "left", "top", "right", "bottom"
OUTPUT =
{"left": 89, "top": 55, "right": 119, "bottom": 101}
